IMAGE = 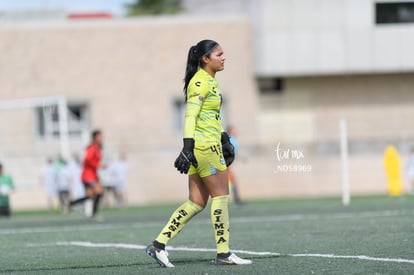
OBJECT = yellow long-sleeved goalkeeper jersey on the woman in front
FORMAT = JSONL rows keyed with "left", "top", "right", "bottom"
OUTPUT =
{"left": 184, "top": 69, "right": 223, "bottom": 149}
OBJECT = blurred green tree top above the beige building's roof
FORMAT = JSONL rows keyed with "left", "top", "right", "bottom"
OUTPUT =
{"left": 127, "top": 0, "right": 183, "bottom": 16}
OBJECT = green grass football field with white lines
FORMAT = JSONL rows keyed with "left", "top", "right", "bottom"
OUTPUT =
{"left": 0, "top": 196, "right": 414, "bottom": 274}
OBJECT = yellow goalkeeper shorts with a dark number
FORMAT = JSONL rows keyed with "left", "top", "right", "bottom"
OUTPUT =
{"left": 188, "top": 144, "right": 227, "bottom": 178}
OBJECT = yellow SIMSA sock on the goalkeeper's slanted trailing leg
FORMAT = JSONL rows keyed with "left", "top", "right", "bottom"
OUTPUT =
{"left": 155, "top": 200, "right": 203, "bottom": 244}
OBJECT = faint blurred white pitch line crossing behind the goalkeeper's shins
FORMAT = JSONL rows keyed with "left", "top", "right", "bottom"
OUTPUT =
{"left": 0, "top": 210, "right": 414, "bottom": 235}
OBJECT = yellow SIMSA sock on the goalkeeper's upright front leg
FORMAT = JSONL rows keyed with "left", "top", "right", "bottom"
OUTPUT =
{"left": 211, "top": 195, "right": 230, "bottom": 254}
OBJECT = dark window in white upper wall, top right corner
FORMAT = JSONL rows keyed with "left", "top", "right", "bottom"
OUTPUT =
{"left": 375, "top": 1, "right": 414, "bottom": 24}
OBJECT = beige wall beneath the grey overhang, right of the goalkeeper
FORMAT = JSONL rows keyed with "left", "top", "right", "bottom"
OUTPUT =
{"left": 256, "top": 73, "right": 414, "bottom": 202}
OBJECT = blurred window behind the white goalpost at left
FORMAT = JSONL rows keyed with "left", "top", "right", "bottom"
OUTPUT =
{"left": 36, "top": 103, "right": 89, "bottom": 139}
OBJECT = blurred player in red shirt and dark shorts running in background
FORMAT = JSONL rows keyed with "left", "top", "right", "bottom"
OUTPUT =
{"left": 69, "top": 130, "right": 105, "bottom": 221}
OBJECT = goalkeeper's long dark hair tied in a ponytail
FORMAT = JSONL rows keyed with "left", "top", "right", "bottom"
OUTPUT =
{"left": 183, "top": 40, "right": 218, "bottom": 100}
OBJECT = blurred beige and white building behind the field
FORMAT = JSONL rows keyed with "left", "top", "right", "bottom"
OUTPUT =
{"left": 0, "top": 0, "right": 414, "bottom": 208}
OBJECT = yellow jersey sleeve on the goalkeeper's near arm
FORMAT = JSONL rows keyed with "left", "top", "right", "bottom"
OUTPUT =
{"left": 184, "top": 81, "right": 209, "bottom": 138}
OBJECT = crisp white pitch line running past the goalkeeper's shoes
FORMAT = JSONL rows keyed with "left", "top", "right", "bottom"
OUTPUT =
{"left": 56, "top": 242, "right": 414, "bottom": 264}
